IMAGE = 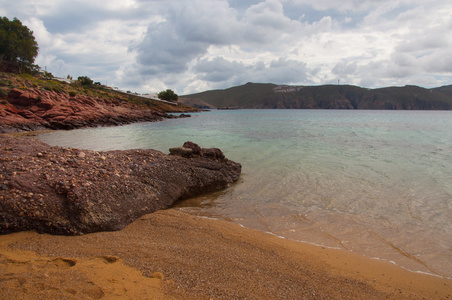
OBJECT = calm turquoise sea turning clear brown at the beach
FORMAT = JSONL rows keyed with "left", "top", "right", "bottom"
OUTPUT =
{"left": 39, "top": 109, "right": 452, "bottom": 278}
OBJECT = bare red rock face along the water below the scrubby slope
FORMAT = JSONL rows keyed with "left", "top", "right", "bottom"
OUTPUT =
{"left": 0, "top": 89, "right": 188, "bottom": 132}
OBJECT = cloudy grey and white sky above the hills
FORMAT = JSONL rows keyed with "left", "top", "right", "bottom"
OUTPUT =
{"left": 0, "top": 0, "right": 452, "bottom": 95}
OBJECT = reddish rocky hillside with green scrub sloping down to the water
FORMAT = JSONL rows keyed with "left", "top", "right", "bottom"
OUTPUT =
{"left": 0, "top": 72, "right": 198, "bottom": 133}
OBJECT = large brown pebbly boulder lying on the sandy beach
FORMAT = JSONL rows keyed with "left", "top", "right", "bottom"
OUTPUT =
{"left": 0, "top": 137, "right": 241, "bottom": 235}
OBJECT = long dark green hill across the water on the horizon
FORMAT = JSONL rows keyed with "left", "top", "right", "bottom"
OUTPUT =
{"left": 179, "top": 82, "right": 452, "bottom": 110}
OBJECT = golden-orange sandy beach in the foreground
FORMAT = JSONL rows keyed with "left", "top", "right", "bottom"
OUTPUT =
{"left": 0, "top": 209, "right": 452, "bottom": 299}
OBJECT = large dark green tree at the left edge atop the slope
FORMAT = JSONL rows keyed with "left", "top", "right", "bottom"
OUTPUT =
{"left": 0, "top": 17, "right": 39, "bottom": 70}
